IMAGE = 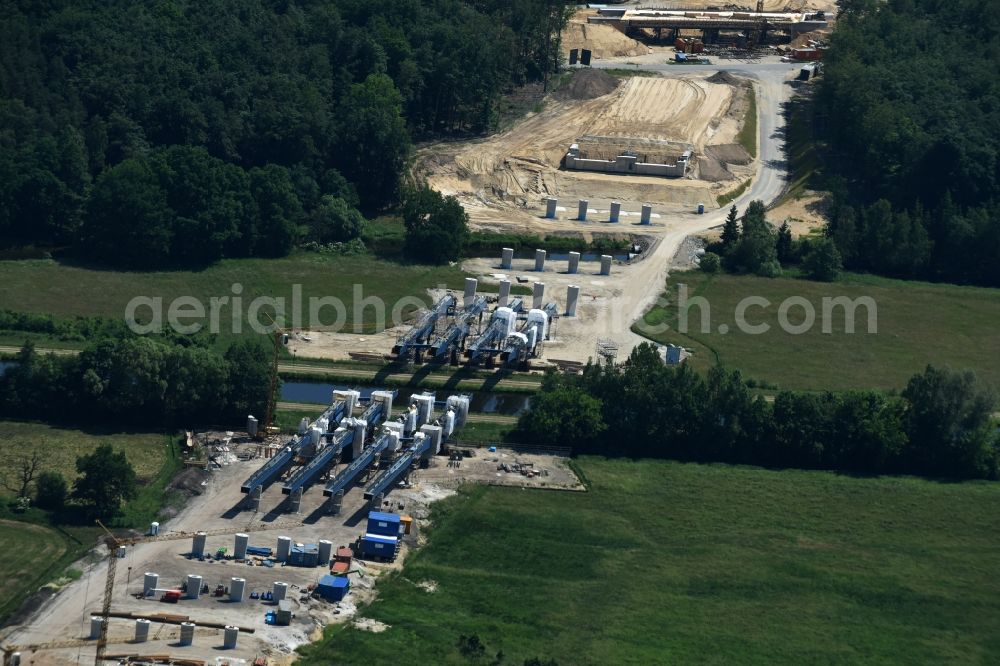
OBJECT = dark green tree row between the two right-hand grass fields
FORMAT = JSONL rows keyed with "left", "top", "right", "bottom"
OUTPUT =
{"left": 519, "top": 343, "right": 1000, "bottom": 479}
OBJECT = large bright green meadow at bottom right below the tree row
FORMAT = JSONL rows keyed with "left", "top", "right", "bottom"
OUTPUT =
{"left": 303, "top": 458, "right": 1000, "bottom": 666}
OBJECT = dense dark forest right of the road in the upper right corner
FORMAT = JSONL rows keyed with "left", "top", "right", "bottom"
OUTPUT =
{"left": 816, "top": 0, "right": 1000, "bottom": 285}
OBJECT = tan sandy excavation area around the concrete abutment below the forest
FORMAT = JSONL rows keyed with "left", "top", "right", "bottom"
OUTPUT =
{"left": 417, "top": 70, "right": 752, "bottom": 233}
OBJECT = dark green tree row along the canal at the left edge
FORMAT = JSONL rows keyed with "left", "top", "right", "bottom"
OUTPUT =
{"left": 0, "top": 334, "right": 271, "bottom": 428}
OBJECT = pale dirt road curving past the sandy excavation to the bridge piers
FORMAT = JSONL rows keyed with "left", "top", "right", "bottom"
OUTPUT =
{"left": 463, "top": 56, "right": 799, "bottom": 362}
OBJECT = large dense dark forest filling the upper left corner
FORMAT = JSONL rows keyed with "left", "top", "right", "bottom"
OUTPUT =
{"left": 0, "top": 0, "right": 566, "bottom": 268}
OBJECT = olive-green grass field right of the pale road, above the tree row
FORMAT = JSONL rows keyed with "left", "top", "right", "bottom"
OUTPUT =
{"left": 636, "top": 272, "right": 1000, "bottom": 390}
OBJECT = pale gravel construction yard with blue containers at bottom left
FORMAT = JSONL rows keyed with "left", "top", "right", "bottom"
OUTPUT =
{"left": 3, "top": 437, "right": 583, "bottom": 666}
